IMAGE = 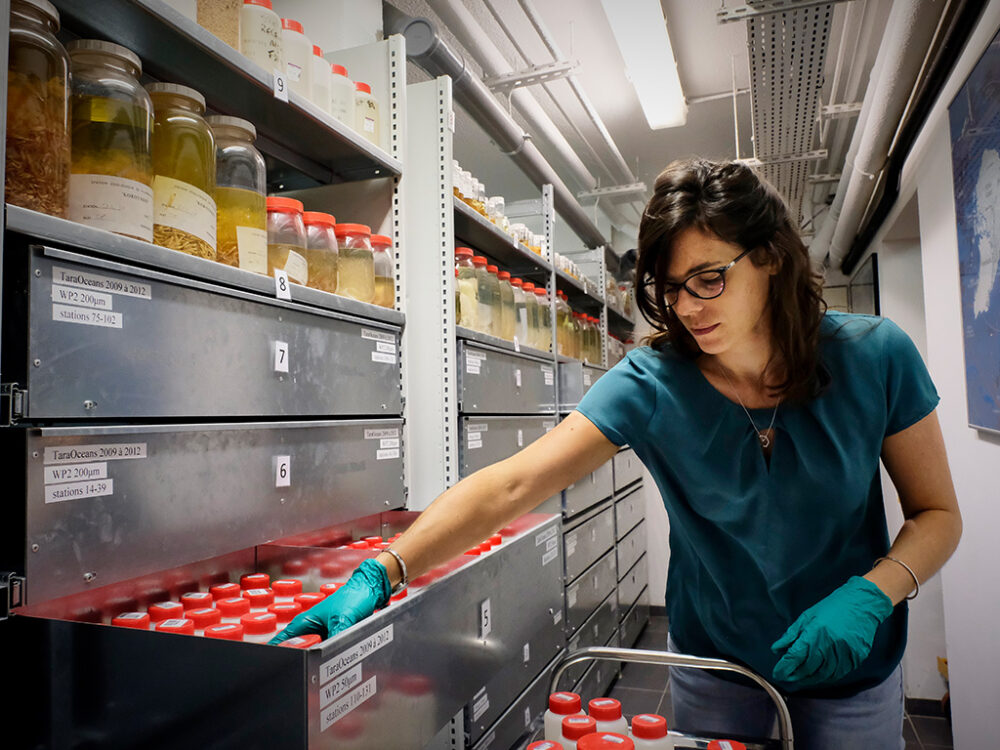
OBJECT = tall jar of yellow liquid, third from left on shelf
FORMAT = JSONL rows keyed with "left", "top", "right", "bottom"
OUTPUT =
{"left": 146, "top": 83, "right": 216, "bottom": 260}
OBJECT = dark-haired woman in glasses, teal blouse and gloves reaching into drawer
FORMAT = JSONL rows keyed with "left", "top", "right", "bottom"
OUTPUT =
{"left": 279, "top": 160, "right": 961, "bottom": 750}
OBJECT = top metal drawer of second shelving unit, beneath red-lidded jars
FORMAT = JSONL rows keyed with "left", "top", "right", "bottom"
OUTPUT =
{"left": 458, "top": 339, "right": 556, "bottom": 414}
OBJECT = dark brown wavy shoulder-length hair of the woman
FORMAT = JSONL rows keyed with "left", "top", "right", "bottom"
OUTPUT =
{"left": 636, "top": 159, "right": 826, "bottom": 402}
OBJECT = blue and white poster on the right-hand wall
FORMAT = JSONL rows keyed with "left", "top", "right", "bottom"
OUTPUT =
{"left": 948, "top": 29, "right": 1000, "bottom": 432}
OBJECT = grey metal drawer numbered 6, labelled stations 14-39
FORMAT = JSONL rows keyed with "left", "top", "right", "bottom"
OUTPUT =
{"left": 6, "top": 419, "right": 405, "bottom": 602}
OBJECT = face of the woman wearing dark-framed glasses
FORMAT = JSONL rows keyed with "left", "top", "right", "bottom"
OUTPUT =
{"left": 667, "top": 227, "right": 773, "bottom": 354}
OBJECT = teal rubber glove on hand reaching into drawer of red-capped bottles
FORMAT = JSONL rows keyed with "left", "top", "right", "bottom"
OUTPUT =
{"left": 268, "top": 560, "right": 392, "bottom": 644}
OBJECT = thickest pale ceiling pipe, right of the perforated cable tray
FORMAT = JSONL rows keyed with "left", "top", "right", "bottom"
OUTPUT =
{"left": 810, "top": 0, "right": 942, "bottom": 269}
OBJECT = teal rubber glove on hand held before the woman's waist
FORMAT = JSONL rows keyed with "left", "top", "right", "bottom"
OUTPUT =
{"left": 771, "top": 576, "right": 892, "bottom": 686}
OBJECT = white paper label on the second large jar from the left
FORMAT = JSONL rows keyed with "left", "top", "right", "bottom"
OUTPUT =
{"left": 68, "top": 174, "right": 153, "bottom": 242}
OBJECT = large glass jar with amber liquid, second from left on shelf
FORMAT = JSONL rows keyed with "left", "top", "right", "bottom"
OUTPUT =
{"left": 67, "top": 39, "right": 153, "bottom": 242}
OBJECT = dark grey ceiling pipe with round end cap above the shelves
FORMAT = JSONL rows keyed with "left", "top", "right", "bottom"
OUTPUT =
{"left": 382, "top": 2, "right": 607, "bottom": 247}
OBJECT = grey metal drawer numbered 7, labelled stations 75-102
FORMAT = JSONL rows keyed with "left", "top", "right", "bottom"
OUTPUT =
{"left": 13, "top": 246, "right": 402, "bottom": 419}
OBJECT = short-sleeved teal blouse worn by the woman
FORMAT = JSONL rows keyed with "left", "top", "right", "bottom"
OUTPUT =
{"left": 578, "top": 312, "right": 938, "bottom": 697}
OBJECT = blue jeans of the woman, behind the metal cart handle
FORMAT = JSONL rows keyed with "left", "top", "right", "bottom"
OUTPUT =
{"left": 667, "top": 636, "right": 905, "bottom": 750}
